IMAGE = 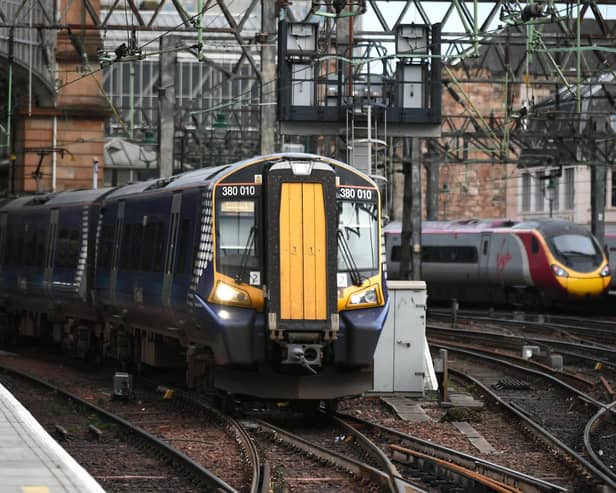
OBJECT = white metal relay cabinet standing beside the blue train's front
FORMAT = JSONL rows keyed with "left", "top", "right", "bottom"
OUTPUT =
{"left": 372, "top": 281, "right": 433, "bottom": 394}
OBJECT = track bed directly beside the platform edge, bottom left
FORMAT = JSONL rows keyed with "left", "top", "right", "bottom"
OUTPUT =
{"left": 0, "top": 367, "right": 237, "bottom": 492}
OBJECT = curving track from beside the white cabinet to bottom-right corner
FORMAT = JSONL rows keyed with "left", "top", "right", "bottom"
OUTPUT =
{"left": 433, "top": 344, "right": 616, "bottom": 490}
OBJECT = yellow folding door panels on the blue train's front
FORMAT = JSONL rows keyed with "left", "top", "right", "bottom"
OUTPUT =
{"left": 279, "top": 182, "right": 327, "bottom": 320}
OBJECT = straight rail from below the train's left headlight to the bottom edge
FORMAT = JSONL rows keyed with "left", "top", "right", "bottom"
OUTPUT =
{"left": 255, "top": 419, "right": 425, "bottom": 493}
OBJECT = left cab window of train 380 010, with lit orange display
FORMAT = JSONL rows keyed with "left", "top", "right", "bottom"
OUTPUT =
{"left": 216, "top": 200, "right": 259, "bottom": 281}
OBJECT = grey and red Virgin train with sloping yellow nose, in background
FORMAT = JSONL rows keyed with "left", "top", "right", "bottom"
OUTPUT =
{"left": 384, "top": 218, "right": 611, "bottom": 306}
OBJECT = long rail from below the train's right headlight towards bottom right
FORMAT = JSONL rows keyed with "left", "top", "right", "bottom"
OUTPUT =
{"left": 338, "top": 413, "right": 568, "bottom": 493}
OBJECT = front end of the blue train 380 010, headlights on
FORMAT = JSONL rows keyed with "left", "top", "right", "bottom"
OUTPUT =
{"left": 187, "top": 154, "right": 388, "bottom": 400}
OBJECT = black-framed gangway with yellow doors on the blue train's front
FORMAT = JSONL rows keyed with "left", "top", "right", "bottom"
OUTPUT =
{"left": 266, "top": 162, "right": 337, "bottom": 338}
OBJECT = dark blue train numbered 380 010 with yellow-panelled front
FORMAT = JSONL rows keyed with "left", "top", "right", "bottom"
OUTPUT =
{"left": 0, "top": 154, "right": 389, "bottom": 402}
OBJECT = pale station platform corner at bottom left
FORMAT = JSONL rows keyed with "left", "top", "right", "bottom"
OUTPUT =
{"left": 0, "top": 385, "right": 105, "bottom": 493}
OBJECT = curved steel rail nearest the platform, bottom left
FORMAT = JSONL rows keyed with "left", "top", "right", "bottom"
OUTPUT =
{"left": 0, "top": 365, "right": 237, "bottom": 493}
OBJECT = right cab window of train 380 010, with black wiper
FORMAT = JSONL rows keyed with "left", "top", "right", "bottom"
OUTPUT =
{"left": 338, "top": 200, "right": 379, "bottom": 272}
